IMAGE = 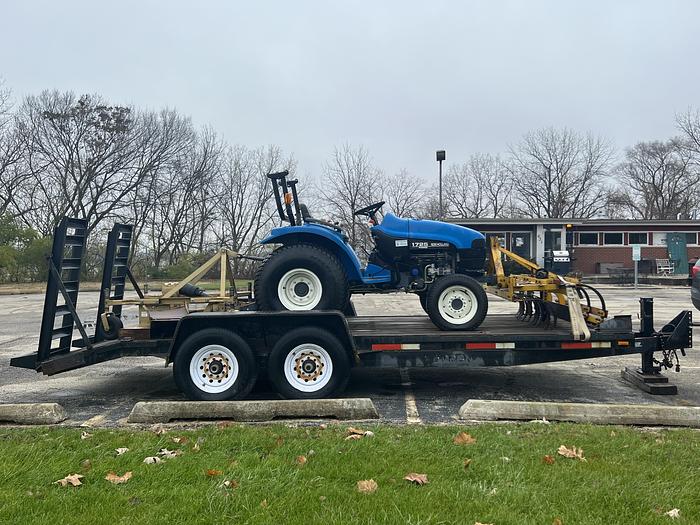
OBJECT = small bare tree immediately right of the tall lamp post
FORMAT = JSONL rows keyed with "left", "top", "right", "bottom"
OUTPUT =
{"left": 443, "top": 153, "right": 512, "bottom": 218}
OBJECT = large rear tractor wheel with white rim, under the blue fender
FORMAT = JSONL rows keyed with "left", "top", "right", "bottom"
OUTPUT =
{"left": 254, "top": 244, "right": 349, "bottom": 311}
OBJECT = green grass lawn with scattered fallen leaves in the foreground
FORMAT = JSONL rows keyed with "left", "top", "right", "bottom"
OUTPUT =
{"left": 0, "top": 423, "right": 700, "bottom": 525}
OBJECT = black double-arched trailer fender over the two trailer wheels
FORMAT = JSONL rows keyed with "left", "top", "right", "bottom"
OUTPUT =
{"left": 165, "top": 310, "right": 359, "bottom": 366}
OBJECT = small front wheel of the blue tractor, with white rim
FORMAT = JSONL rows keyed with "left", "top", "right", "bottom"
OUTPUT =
{"left": 426, "top": 274, "right": 488, "bottom": 330}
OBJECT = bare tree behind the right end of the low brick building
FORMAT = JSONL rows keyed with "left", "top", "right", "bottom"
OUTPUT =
{"left": 610, "top": 139, "right": 700, "bottom": 219}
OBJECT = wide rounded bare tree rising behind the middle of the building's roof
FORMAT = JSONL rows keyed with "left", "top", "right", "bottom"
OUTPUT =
{"left": 508, "top": 128, "right": 613, "bottom": 218}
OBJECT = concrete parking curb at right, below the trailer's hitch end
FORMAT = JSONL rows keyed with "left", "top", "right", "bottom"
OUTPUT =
{"left": 459, "top": 399, "right": 700, "bottom": 428}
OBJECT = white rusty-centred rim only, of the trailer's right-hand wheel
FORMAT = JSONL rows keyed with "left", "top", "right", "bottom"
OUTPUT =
{"left": 284, "top": 343, "right": 333, "bottom": 392}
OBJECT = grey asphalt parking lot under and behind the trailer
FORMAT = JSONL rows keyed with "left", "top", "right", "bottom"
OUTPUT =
{"left": 0, "top": 286, "right": 700, "bottom": 426}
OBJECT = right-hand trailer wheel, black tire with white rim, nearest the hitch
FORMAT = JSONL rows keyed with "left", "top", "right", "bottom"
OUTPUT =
{"left": 267, "top": 327, "right": 350, "bottom": 399}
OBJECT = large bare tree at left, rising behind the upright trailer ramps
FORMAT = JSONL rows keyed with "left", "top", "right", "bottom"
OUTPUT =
{"left": 19, "top": 91, "right": 194, "bottom": 234}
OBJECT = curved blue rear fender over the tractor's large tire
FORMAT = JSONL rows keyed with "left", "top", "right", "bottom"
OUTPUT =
{"left": 260, "top": 224, "right": 362, "bottom": 284}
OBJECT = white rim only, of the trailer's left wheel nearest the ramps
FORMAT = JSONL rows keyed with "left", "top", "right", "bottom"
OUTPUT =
{"left": 190, "top": 345, "right": 239, "bottom": 394}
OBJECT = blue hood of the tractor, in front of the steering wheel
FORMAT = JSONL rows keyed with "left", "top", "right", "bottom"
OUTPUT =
{"left": 373, "top": 213, "right": 485, "bottom": 250}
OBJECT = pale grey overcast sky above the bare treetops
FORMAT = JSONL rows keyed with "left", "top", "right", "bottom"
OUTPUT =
{"left": 0, "top": 0, "right": 700, "bottom": 179}
